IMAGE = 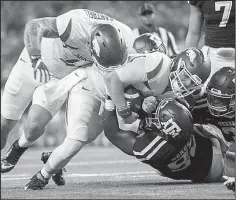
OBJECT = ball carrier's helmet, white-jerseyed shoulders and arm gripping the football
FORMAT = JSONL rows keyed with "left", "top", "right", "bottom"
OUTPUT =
{"left": 104, "top": 48, "right": 211, "bottom": 124}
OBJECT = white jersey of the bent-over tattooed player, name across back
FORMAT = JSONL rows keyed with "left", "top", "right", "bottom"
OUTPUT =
{"left": 45, "top": 9, "right": 134, "bottom": 78}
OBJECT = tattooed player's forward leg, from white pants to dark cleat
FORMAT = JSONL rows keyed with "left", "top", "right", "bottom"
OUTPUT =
{"left": 2, "top": 79, "right": 67, "bottom": 172}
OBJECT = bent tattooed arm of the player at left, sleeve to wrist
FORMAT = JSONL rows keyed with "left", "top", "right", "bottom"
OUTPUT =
{"left": 24, "top": 17, "right": 59, "bottom": 57}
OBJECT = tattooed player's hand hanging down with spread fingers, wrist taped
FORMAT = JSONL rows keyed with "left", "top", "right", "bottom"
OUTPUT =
{"left": 31, "top": 57, "right": 51, "bottom": 83}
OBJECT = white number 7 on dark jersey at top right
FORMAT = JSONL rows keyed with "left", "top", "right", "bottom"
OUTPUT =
{"left": 215, "top": 1, "right": 232, "bottom": 27}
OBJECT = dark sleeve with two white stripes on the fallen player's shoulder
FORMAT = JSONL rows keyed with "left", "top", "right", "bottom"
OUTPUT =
{"left": 133, "top": 133, "right": 173, "bottom": 163}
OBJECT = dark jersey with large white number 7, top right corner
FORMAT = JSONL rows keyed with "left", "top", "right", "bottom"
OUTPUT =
{"left": 189, "top": 0, "right": 235, "bottom": 48}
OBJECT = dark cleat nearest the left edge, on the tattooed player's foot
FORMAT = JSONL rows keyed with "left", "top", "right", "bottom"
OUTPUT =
{"left": 1, "top": 140, "right": 28, "bottom": 173}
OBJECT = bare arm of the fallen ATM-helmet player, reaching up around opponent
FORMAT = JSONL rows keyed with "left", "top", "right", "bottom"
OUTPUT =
{"left": 104, "top": 99, "right": 136, "bottom": 156}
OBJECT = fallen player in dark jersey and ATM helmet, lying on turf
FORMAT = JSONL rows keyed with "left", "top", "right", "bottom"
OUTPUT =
{"left": 104, "top": 99, "right": 232, "bottom": 182}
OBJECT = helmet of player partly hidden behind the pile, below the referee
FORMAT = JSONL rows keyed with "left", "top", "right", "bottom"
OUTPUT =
{"left": 133, "top": 33, "right": 166, "bottom": 54}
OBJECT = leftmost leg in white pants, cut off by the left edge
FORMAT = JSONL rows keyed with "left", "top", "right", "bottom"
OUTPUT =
{"left": 1, "top": 49, "right": 41, "bottom": 150}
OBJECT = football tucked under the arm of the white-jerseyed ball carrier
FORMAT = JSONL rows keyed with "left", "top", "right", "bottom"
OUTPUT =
{"left": 124, "top": 85, "right": 142, "bottom": 113}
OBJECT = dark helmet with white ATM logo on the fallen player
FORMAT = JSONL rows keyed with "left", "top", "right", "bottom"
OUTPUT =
{"left": 146, "top": 99, "right": 193, "bottom": 140}
